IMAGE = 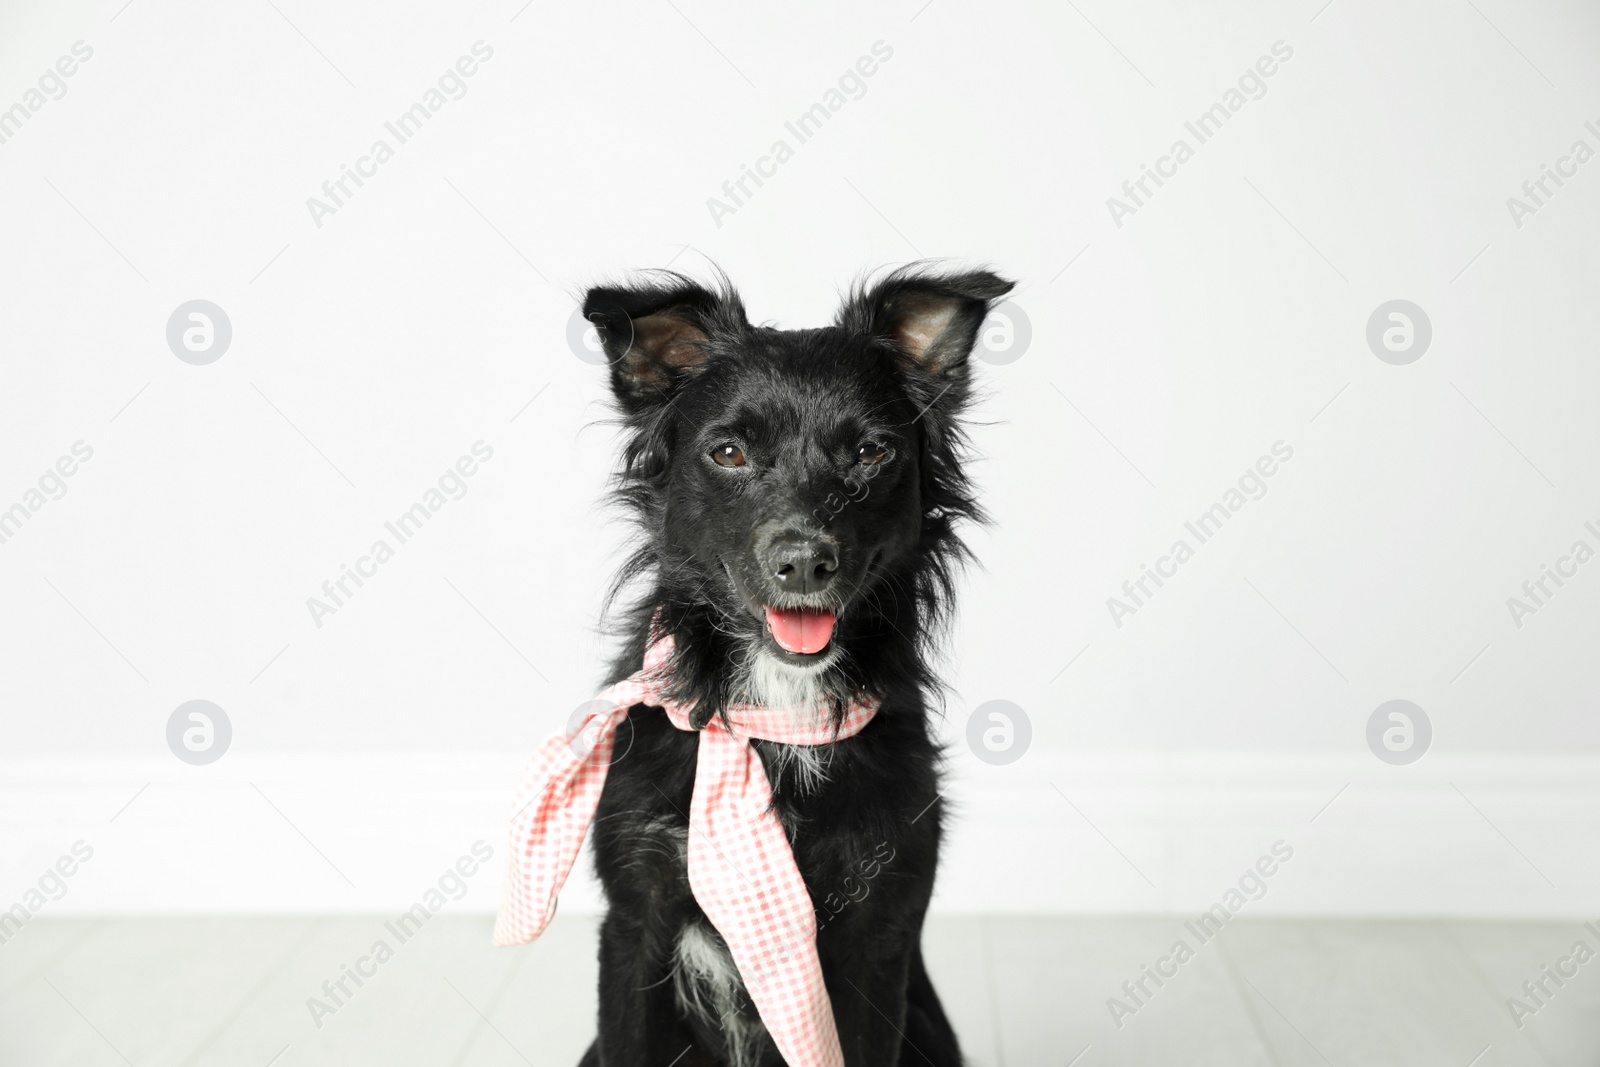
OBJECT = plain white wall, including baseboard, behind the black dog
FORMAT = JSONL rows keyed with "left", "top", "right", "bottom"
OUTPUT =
{"left": 0, "top": 0, "right": 1600, "bottom": 913}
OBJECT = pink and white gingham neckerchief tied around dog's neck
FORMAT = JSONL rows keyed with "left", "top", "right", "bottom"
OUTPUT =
{"left": 494, "top": 635, "right": 878, "bottom": 1067}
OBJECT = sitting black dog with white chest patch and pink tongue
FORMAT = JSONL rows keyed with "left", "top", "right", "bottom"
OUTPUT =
{"left": 582, "top": 266, "right": 1011, "bottom": 1067}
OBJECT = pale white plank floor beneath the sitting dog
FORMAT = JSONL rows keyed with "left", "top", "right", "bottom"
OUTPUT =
{"left": 0, "top": 915, "right": 1600, "bottom": 1067}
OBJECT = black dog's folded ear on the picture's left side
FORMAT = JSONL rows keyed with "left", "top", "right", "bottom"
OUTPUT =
{"left": 584, "top": 275, "right": 742, "bottom": 414}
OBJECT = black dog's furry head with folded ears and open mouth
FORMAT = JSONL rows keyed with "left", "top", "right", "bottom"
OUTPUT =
{"left": 584, "top": 267, "right": 1011, "bottom": 716}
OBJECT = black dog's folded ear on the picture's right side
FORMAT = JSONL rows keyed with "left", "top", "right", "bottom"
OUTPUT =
{"left": 840, "top": 264, "right": 1013, "bottom": 376}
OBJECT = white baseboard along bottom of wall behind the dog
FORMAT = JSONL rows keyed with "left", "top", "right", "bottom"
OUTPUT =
{"left": 0, "top": 750, "right": 1600, "bottom": 918}
